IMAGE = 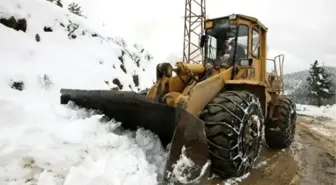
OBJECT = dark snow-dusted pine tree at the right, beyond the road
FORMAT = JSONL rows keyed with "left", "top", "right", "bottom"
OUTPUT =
{"left": 307, "top": 60, "right": 334, "bottom": 107}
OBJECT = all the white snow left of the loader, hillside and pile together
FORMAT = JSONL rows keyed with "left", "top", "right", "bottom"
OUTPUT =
{"left": 0, "top": 0, "right": 166, "bottom": 185}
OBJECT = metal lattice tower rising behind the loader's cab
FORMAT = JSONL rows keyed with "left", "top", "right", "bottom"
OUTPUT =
{"left": 183, "top": 0, "right": 206, "bottom": 63}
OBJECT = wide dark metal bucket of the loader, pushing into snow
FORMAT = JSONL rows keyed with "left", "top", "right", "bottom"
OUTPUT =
{"left": 61, "top": 89, "right": 210, "bottom": 185}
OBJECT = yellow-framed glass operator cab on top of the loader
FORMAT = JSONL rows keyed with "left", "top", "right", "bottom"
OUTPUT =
{"left": 201, "top": 14, "right": 267, "bottom": 80}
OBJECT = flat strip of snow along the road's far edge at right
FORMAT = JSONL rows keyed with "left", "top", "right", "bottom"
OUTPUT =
{"left": 296, "top": 104, "right": 336, "bottom": 120}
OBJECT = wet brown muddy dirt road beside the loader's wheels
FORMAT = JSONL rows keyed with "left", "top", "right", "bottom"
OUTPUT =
{"left": 211, "top": 116, "right": 336, "bottom": 185}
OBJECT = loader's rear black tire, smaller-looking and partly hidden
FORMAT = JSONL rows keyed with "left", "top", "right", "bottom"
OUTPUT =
{"left": 265, "top": 96, "right": 296, "bottom": 149}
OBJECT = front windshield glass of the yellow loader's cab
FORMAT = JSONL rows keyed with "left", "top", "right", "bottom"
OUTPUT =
{"left": 204, "top": 19, "right": 248, "bottom": 66}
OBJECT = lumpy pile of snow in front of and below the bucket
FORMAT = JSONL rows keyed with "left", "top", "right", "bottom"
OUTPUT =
{"left": 0, "top": 100, "right": 166, "bottom": 185}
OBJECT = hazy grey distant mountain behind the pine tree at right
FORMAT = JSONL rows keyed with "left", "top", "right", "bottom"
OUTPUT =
{"left": 284, "top": 66, "right": 336, "bottom": 104}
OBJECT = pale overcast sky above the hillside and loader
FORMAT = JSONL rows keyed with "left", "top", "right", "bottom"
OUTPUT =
{"left": 71, "top": 0, "right": 336, "bottom": 72}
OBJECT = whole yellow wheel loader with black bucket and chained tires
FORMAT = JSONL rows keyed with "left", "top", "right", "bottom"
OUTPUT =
{"left": 61, "top": 14, "right": 296, "bottom": 184}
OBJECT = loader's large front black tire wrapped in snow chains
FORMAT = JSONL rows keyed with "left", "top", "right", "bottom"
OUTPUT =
{"left": 201, "top": 91, "right": 264, "bottom": 179}
